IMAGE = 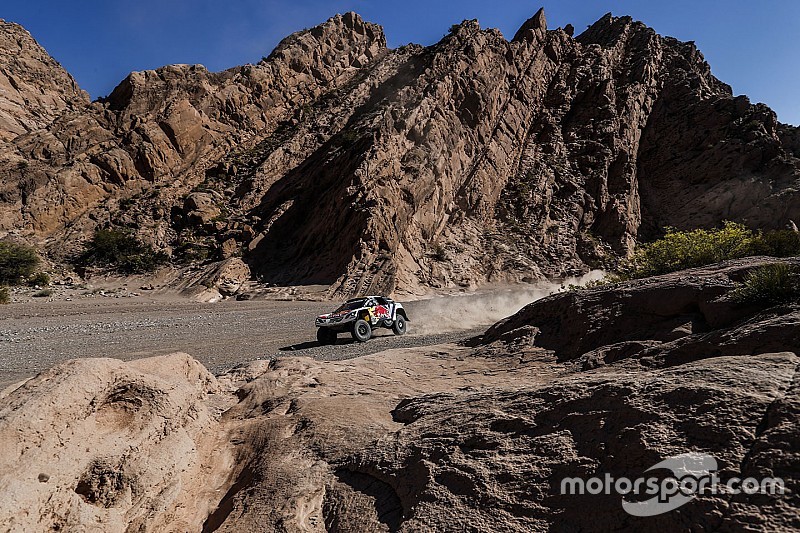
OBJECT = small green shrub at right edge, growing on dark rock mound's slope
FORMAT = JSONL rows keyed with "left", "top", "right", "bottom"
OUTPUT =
{"left": 730, "top": 263, "right": 800, "bottom": 304}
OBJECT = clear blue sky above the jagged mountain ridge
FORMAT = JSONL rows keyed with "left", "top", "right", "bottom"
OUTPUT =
{"left": 0, "top": 0, "right": 800, "bottom": 125}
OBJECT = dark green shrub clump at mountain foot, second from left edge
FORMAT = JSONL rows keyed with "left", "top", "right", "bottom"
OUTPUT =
{"left": 81, "top": 229, "right": 168, "bottom": 274}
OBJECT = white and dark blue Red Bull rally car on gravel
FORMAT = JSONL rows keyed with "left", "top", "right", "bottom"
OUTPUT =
{"left": 315, "top": 296, "right": 409, "bottom": 344}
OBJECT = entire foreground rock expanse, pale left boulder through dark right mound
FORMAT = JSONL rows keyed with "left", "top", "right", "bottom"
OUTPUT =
{"left": 0, "top": 259, "right": 800, "bottom": 532}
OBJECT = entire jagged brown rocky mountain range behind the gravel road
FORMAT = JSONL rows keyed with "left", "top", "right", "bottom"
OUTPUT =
{"left": 0, "top": 10, "right": 800, "bottom": 296}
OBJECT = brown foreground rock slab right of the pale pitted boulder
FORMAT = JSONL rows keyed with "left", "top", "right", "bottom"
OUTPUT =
{"left": 208, "top": 353, "right": 800, "bottom": 531}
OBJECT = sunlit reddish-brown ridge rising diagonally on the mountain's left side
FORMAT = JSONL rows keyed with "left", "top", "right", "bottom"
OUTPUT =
{"left": 0, "top": 11, "right": 385, "bottom": 240}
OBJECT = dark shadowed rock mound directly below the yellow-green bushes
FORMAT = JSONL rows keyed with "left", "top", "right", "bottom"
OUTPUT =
{"left": 477, "top": 258, "right": 800, "bottom": 368}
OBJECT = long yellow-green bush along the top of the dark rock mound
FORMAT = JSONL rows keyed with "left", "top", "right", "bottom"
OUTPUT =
{"left": 616, "top": 222, "right": 800, "bottom": 281}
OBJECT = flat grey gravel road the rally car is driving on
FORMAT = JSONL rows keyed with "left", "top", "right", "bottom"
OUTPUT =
{"left": 0, "top": 297, "right": 489, "bottom": 389}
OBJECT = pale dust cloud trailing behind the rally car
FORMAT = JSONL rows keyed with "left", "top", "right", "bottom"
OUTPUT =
{"left": 407, "top": 270, "right": 605, "bottom": 334}
